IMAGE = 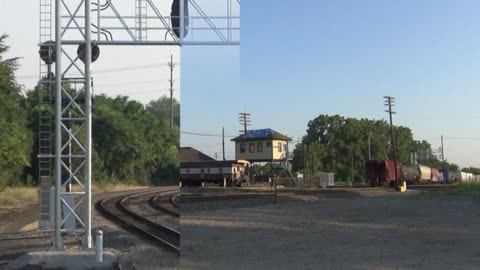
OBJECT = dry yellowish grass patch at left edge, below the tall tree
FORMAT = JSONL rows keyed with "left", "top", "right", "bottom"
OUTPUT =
{"left": 0, "top": 187, "right": 38, "bottom": 209}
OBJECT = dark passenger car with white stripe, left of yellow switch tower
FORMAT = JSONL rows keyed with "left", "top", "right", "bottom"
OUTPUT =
{"left": 180, "top": 160, "right": 249, "bottom": 186}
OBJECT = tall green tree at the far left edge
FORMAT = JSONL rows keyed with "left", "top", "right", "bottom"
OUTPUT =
{"left": 0, "top": 35, "right": 32, "bottom": 190}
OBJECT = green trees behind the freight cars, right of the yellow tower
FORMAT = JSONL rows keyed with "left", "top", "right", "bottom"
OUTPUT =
{"left": 292, "top": 114, "right": 475, "bottom": 184}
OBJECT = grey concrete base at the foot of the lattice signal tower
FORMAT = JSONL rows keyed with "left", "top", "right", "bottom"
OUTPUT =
{"left": 6, "top": 250, "right": 118, "bottom": 270}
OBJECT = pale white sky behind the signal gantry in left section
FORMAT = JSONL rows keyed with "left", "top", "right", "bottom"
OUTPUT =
{"left": 0, "top": 0, "right": 181, "bottom": 104}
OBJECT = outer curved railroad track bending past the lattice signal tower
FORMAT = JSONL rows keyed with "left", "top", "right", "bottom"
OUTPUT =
{"left": 96, "top": 189, "right": 180, "bottom": 254}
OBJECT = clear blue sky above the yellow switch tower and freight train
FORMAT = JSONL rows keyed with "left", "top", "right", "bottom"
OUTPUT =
{"left": 181, "top": 0, "right": 480, "bottom": 167}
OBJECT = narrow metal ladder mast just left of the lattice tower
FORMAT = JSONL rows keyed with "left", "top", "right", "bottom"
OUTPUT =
{"left": 38, "top": 0, "right": 53, "bottom": 230}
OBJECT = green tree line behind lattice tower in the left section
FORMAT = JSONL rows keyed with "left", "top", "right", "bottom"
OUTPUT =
{"left": 0, "top": 35, "right": 180, "bottom": 191}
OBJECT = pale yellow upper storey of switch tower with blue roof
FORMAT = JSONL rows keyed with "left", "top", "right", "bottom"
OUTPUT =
{"left": 231, "top": 128, "right": 290, "bottom": 162}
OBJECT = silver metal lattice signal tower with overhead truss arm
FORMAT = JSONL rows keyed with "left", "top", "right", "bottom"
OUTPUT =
{"left": 39, "top": 0, "right": 240, "bottom": 249}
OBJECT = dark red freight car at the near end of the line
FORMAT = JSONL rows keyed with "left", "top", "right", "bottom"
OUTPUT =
{"left": 365, "top": 160, "right": 402, "bottom": 187}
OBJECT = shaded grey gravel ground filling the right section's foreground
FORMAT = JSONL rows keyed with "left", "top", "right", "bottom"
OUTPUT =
{"left": 180, "top": 188, "right": 480, "bottom": 270}
